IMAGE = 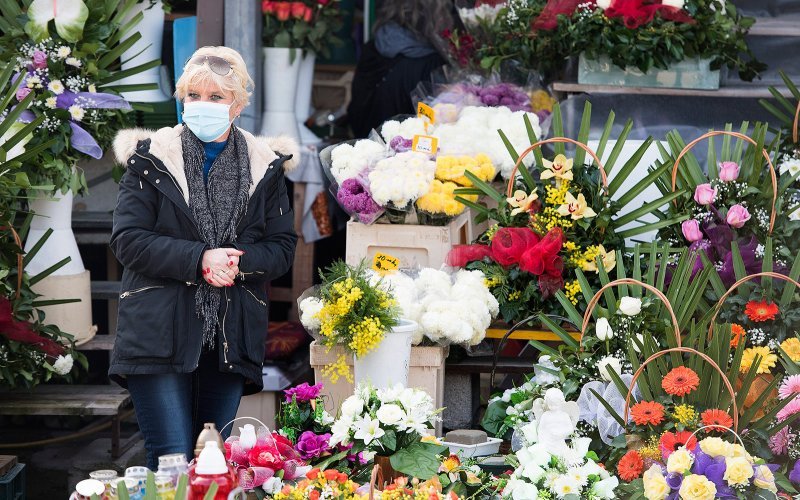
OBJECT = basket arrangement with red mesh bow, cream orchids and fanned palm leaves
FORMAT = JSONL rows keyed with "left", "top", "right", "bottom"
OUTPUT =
{"left": 449, "top": 103, "right": 682, "bottom": 324}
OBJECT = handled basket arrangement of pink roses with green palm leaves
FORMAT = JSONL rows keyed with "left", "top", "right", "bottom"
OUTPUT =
{"left": 656, "top": 123, "right": 800, "bottom": 286}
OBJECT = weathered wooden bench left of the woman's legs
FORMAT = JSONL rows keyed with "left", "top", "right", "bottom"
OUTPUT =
{"left": 0, "top": 385, "right": 140, "bottom": 459}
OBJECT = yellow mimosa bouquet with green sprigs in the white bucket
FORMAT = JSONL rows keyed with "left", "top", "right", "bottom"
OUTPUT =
{"left": 299, "top": 261, "right": 400, "bottom": 383}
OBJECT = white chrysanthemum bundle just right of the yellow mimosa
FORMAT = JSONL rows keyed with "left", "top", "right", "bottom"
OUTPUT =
{"left": 376, "top": 268, "right": 498, "bottom": 346}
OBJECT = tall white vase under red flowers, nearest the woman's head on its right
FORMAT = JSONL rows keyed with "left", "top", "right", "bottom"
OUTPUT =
{"left": 261, "top": 47, "right": 303, "bottom": 140}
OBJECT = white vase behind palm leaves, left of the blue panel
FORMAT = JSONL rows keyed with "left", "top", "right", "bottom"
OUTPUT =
{"left": 119, "top": 0, "right": 169, "bottom": 102}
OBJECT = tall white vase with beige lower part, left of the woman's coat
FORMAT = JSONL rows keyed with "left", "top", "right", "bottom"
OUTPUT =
{"left": 25, "top": 191, "right": 97, "bottom": 345}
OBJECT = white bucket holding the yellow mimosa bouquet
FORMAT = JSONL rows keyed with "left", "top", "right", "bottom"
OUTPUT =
{"left": 353, "top": 319, "right": 418, "bottom": 389}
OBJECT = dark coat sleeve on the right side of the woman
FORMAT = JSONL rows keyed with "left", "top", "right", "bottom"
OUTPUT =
{"left": 236, "top": 169, "right": 297, "bottom": 281}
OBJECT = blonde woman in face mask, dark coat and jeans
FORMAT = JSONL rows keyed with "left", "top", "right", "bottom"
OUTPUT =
{"left": 109, "top": 47, "right": 298, "bottom": 470}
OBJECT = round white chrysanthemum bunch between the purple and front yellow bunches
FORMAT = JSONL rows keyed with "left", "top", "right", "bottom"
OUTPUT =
{"left": 369, "top": 151, "right": 436, "bottom": 207}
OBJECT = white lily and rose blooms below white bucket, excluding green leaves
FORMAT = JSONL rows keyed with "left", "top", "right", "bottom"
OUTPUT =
{"left": 330, "top": 384, "right": 439, "bottom": 453}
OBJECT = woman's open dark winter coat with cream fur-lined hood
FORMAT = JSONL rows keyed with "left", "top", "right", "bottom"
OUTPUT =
{"left": 109, "top": 125, "right": 299, "bottom": 394}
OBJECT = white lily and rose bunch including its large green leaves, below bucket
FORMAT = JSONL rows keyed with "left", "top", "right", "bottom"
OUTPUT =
{"left": 330, "top": 384, "right": 446, "bottom": 481}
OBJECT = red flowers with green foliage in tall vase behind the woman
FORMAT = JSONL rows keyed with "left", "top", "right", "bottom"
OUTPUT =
{"left": 261, "top": 0, "right": 343, "bottom": 58}
